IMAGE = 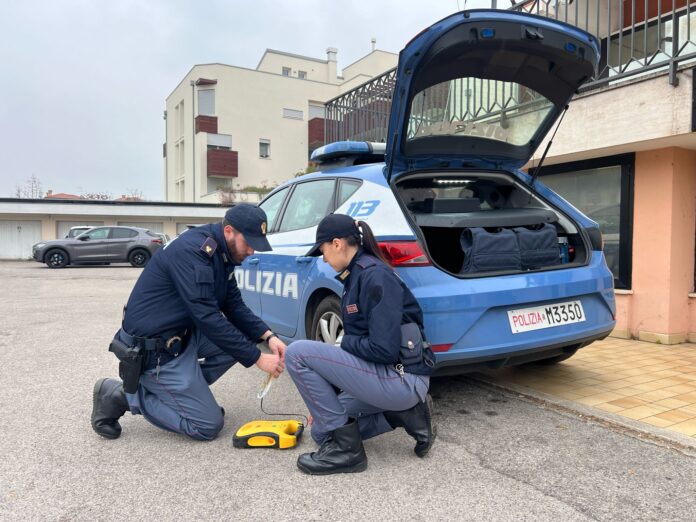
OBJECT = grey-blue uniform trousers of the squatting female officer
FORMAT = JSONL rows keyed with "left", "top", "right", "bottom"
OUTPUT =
{"left": 285, "top": 341, "right": 430, "bottom": 444}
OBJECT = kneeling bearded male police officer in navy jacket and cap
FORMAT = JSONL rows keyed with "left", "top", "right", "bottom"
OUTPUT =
{"left": 92, "top": 204, "right": 285, "bottom": 440}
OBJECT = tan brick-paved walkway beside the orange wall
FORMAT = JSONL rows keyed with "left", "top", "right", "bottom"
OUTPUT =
{"left": 476, "top": 337, "right": 696, "bottom": 438}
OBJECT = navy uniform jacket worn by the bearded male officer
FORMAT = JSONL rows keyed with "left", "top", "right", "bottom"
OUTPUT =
{"left": 123, "top": 223, "right": 269, "bottom": 367}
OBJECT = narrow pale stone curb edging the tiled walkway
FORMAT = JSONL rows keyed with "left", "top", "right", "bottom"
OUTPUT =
{"left": 467, "top": 374, "right": 696, "bottom": 457}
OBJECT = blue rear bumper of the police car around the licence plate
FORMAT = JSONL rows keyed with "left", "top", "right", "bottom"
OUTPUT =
{"left": 400, "top": 252, "right": 616, "bottom": 371}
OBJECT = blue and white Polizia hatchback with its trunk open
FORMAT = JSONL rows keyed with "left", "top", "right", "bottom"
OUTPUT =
{"left": 235, "top": 10, "right": 616, "bottom": 373}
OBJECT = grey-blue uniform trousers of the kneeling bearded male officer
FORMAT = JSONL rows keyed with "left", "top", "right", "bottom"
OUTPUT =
{"left": 126, "top": 331, "right": 237, "bottom": 440}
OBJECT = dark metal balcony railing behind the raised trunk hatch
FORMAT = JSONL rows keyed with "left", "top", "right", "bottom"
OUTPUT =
{"left": 324, "top": 0, "right": 696, "bottom": 143}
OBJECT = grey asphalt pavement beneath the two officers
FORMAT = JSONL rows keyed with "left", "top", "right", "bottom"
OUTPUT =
{"left": 0, "top": 262, "right": 696, "bottom": 521}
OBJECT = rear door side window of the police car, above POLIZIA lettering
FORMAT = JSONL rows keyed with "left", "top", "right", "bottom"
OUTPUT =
{"left": 279, "top": 179, "right": 334, "bottom": 232}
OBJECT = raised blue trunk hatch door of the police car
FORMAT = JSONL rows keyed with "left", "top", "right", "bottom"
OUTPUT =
{"left": 385, "top": 9, "right": 600, "bottom": 182}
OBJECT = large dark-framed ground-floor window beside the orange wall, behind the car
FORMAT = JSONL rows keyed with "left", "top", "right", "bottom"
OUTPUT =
{"left": 541, "top": 154, "right": 635, "bottom": 289}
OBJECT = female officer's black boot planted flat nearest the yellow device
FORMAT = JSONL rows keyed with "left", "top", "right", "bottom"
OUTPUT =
{"left": 297, "top": 419, "right": 367, "bottom": 475}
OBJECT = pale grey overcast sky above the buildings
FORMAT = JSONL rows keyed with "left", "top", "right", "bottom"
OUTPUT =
{"left": 0, "top": 0, "right": 492, "bottom": 200}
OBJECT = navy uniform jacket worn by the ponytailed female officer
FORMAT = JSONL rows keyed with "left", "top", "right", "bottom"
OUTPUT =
{"left": 336, "top": 249, "right": 429, "bottom": 373}
